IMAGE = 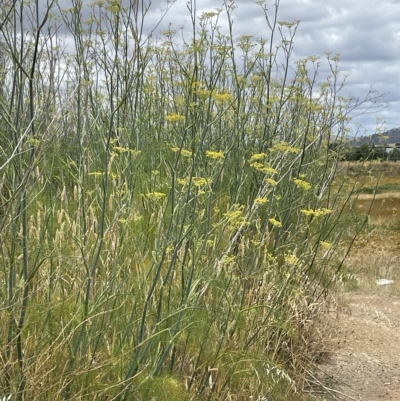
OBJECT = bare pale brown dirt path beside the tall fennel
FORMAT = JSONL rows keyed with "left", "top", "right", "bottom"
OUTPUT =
{"left": 317, "top": 294, "right": 400, "bottom": 401}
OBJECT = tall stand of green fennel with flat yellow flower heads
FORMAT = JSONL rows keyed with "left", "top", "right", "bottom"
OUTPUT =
{"left": 0, "top": 0, "right": 382, "bottom": 401}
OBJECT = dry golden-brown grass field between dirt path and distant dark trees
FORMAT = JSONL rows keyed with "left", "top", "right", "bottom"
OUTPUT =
{"left": 340, "top": 162, "right": 400, "bottom": 295}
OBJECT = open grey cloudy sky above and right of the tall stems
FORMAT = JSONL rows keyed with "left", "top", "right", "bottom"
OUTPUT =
{"left": 140, "top": 0, "right": 400, "bottom": 135}
